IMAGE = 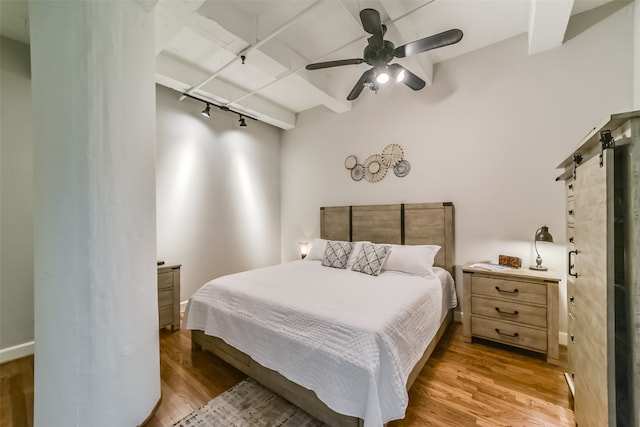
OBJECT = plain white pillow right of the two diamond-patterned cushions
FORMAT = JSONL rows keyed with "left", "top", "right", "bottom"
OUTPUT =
{"left": 382, "top": 245, "right": 440, "bottom": 278}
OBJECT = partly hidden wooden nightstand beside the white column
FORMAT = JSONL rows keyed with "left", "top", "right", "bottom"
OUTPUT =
{"left": 158, "top": 264, "right": 181, "bottom": 331}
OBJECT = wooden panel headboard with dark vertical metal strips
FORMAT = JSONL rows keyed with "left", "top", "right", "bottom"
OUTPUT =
{"left": 320, "top": 202, "right": 455, "bottom": 274}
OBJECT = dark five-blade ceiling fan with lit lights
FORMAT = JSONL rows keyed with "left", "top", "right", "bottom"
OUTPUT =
{"left": 305, "top": 9, "right": 462, "bottom": 101}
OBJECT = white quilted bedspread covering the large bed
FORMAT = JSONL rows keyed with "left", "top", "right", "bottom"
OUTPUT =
{"left": 186, "top": 261, "right": 456, "bottom": 427}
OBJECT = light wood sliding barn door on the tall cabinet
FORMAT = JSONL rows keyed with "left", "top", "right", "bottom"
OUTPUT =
{"left": 572, "top": 153, "right": 615, "bottom": 426}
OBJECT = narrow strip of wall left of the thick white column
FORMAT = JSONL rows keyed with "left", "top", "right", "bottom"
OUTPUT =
{"left": 0, "top": 37, "right": 33, "bottom": 363}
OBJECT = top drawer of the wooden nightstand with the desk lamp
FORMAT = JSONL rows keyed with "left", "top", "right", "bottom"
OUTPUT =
{"left": 471, "top": 275, "right": 547, "bottom": 305}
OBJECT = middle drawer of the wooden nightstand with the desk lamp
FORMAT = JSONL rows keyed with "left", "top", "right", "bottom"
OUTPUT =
{"left": 471, "top": 296, "right": 547, "bottom": 328}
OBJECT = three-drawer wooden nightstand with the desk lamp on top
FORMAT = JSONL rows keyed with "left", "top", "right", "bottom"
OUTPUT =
{"left": 462, "top": 264, "right": 560, "bottom": 365}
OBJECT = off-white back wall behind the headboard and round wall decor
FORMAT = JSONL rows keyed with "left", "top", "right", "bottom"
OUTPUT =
{"left": 281, "top": 6, "right": 633, "bottom": 336}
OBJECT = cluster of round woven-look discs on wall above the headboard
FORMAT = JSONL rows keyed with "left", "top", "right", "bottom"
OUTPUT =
{"left": 344, "top": 144, "right": 411, "bottom": 183}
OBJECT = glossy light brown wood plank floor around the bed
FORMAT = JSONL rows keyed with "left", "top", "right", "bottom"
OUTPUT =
{"left": 0, "top": 324, "right": 575, "bottom": 427}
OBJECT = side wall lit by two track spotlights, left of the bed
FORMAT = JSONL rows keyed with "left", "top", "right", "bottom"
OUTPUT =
{"left": 156, "top": 85, "right": 280, "bottom": 301}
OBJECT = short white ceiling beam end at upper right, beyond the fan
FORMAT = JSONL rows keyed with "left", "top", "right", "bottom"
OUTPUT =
{"left": 529, "top": 0, "right": 574, "bottom": 55}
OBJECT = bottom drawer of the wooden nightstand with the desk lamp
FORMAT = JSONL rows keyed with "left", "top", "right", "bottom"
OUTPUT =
{"left": 471, "top": 316, "right": 547, "bottom": 352}
